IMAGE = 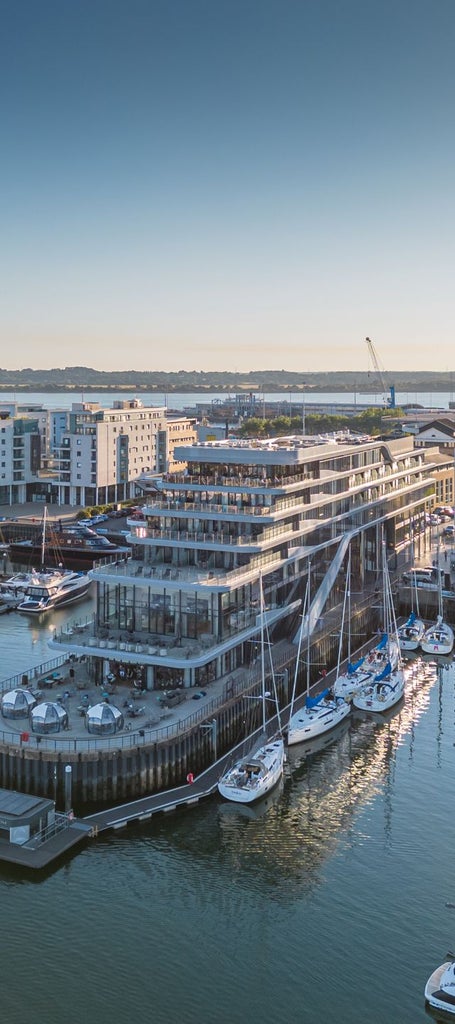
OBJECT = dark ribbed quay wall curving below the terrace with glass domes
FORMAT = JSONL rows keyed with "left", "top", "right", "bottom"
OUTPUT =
{"left": 0, "top": 601, "right": 380, "bottom": 813}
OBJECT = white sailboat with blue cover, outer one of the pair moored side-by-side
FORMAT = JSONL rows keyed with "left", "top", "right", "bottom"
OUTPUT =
{"left": 353, "top": 545, "right": 405, "bottom": 713}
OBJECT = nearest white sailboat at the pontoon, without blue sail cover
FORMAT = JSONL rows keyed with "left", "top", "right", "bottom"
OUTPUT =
{"left": 218, "top": 582, "right": 284, "bottom": 804}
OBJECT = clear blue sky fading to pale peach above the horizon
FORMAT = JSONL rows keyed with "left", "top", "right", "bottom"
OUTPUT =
{"left": 0, "top": 0, "right": 455, "bottom": 373}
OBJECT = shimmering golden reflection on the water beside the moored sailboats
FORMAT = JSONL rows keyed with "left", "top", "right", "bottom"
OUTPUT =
{"left": 218, "top": 662, "right": 445, "bottom": 895}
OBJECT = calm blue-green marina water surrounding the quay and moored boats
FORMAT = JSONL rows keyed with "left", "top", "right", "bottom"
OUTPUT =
{"left": 0, "top": 602, "right": 455, "bottom": 1024}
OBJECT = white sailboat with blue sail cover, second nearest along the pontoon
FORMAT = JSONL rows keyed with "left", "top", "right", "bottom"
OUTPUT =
{"left": 288, "top": 563, "right": 350, "bottom": 746}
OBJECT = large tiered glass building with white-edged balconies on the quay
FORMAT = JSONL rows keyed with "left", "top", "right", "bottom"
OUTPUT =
{"left": 52, "top": 437, "right": 435, "bottom": 689}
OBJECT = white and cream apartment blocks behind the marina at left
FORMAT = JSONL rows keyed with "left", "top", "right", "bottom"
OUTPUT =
{"left": 0, "top": 399, "right": 196, "bottom": 506}
